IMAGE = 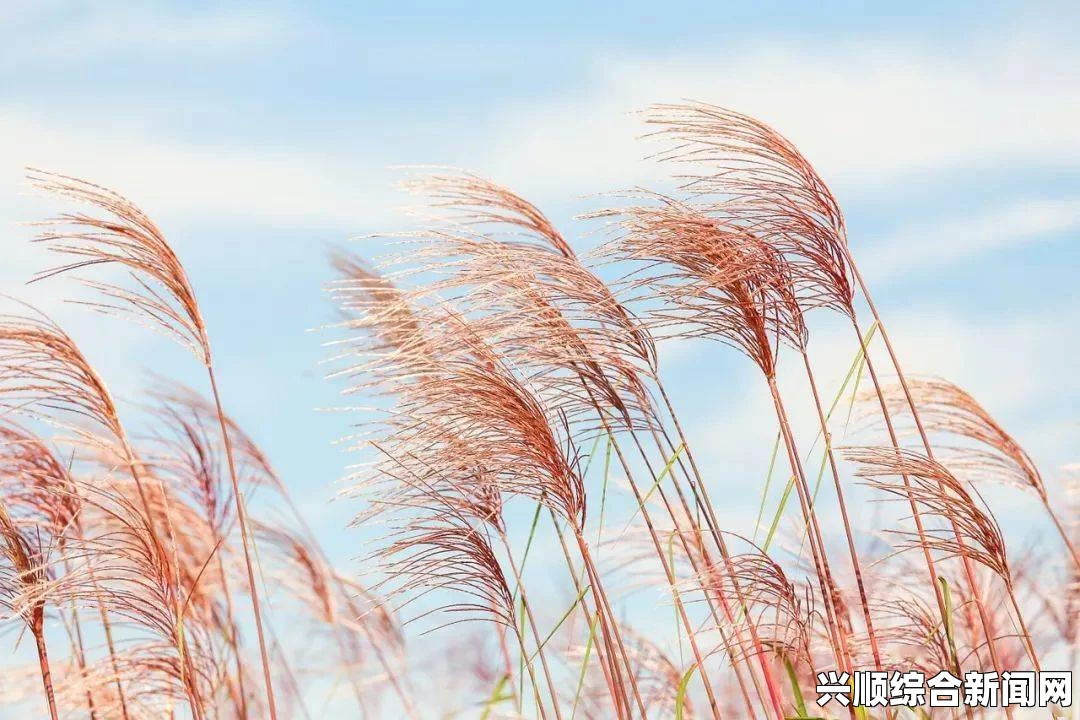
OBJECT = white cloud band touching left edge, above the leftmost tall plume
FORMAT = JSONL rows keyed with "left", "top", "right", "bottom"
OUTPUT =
{"left": 0, "top": 104, "right": 392, "bottom": 234}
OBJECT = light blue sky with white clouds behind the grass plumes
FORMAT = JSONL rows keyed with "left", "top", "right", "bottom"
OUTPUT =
{"left": 0, "top": 0, "right": 1080, "bottom": 703}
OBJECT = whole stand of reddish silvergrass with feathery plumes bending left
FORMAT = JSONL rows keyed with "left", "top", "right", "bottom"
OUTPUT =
{"left": 0, "top": 103, "right": 1080, "bottom": 720}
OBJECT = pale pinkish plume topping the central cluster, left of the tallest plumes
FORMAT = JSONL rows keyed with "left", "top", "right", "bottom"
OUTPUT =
{"left": 366, "top": 174, "right": 656, "bottom": 425}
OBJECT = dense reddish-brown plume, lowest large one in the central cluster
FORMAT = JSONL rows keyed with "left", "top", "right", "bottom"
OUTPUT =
{"left": 347, "top": 304, "right": 585, "bottom": 527}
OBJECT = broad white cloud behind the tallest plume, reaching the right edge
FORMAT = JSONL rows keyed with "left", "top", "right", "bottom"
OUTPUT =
{"left": 477, "top": 30, "right": 1080, "bottom": 199}
